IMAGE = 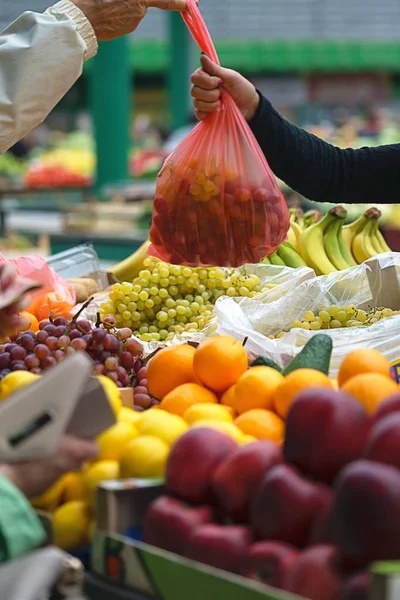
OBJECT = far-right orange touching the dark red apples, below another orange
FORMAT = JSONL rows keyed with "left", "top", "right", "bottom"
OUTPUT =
{"left": 342, "top": 373, "right": 399, "bottom": 415}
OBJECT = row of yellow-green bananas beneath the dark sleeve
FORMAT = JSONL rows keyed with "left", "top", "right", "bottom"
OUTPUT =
{"left": 263, "top": 206, "right": 391, "bottom": 275}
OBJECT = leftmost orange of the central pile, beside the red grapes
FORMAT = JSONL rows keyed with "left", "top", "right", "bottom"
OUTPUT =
{"left": 147, "top": 344, "right": 196, "bottom": 400}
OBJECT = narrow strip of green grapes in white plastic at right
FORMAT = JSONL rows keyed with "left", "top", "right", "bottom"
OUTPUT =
{"left": 268, "top": 304, "right": 400, "bottom": 339}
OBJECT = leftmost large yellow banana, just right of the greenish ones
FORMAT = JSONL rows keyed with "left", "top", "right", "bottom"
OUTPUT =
{"left": 299, "top": 212, "right": 337, "bottom": 275}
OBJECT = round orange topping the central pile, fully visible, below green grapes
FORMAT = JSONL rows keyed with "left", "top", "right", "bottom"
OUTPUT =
{"left": 193, "top": 335, "right": 248, "bottom": 392}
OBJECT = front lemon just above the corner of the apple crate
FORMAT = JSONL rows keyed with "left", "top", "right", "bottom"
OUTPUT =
{"left": 120, "top": 435, "right": 169, "bottom": 478}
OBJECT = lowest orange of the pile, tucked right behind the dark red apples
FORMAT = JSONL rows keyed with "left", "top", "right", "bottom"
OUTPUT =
{"left": 235, "top": 408, "right": 285, "bottom": 444}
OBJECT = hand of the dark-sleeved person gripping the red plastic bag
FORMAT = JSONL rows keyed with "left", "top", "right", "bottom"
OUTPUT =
{"left": 191, "top": 54, "right": 260, "bottom": 121}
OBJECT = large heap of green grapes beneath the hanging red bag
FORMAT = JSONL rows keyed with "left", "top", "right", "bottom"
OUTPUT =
{"left": 100, "top": 257, "right": 271, "bottom": 342}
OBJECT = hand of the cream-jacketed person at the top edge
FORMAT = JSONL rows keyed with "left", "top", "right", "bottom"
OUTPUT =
{"left": 72, "top": 0, "right": 193, "bottom": 41}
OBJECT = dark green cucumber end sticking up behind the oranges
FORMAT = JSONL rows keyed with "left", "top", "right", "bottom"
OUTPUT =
{"left": 283, "top": 333, "right": 333, "bottom": 376}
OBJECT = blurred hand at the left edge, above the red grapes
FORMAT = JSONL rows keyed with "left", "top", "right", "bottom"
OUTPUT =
{"left": 0, "top": 262, "right": 29, "bottom": 342}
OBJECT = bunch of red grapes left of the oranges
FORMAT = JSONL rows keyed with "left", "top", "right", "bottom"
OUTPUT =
{"left": 0, "top": 317, "right": 143, "bottom": 388}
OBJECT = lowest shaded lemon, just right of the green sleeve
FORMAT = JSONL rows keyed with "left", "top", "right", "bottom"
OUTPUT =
{"left": 52, "top": 500, "right": 91, "bottom": 552}
